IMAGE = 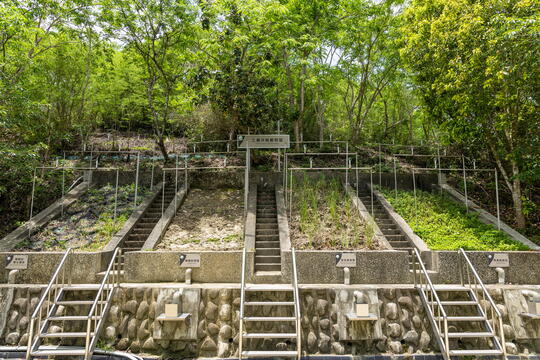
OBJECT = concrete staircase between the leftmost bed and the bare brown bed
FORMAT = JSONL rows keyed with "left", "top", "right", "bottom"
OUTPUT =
{"left": 121, "top": 182, "right": 175, "bottom": 252}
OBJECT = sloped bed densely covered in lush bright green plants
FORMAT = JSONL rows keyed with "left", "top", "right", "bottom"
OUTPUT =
{"left": 380, "top": 188, "right": 528, "bottom": 251}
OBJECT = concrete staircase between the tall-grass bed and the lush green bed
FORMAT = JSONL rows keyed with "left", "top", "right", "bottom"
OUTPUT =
{"left": 358, "top": 188, "right": 414, "bottom": 269}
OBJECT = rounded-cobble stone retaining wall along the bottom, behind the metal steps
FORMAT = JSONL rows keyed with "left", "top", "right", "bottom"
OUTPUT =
{"left": 0, "top": 285, "right": 540, "bottom": 358}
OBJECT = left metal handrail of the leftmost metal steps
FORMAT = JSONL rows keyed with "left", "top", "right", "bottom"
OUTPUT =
{"left": 26, "top": 248, "right": 72, "bottom": 359}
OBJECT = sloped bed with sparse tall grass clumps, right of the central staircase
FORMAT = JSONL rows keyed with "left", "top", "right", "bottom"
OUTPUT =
{"left": 289, "top": 176, "right": 382, "bottom": 250}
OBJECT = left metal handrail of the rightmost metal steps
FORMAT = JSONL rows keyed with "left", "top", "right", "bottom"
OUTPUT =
{"left": 413, "top": 248, "right": 450, "bottom": 358}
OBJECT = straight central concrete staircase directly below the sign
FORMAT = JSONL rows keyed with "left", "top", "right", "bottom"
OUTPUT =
{"left": 255, "top": 186, "right": 281, "bottom": 272}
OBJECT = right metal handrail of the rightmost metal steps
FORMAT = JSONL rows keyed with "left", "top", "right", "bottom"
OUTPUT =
{"left": 458, "top": 248, "right": 506, "bottom": 359}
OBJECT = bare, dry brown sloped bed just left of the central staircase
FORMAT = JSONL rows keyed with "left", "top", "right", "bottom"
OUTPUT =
{"left": 156, "top": 189, "right": 244, "bottom": 251}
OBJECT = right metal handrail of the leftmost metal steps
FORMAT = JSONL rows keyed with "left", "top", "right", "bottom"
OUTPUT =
{"left": 84, "top": 248, "right": 122, "bottom": 359}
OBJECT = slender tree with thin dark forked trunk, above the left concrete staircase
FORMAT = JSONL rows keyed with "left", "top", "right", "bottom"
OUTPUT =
{"left": 103, "top": 0, "right": 198, "bottom": 160}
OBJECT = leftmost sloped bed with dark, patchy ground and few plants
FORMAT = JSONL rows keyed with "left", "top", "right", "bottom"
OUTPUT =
{"left": 16, "top": 185, "right": 150, "bottom": 251}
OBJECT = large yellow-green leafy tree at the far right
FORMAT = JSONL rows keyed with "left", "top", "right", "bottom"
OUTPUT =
{"left": 403, "top": 0, "right": 540, "bottom": 228}
